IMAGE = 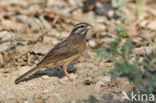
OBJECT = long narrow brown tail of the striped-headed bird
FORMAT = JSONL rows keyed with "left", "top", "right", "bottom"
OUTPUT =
{"left": 15, "top": 66, "right": 39, "bottom": 84}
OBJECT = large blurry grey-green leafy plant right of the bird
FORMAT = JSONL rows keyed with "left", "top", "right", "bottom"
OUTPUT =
{"left": 94, "top": 26, "right": 156, "bottom": 93}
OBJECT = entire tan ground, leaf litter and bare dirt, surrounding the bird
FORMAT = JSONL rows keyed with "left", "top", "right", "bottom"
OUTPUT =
{"left": 0, "top": 0, "right": 156, "bottom": 103}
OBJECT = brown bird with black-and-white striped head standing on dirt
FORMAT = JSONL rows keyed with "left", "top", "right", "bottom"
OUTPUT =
{"left": 15, "top": 22, "right": 93, "bottom": 84}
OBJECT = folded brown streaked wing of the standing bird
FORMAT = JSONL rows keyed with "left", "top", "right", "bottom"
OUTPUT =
{"left": 38, "top": 35, "right": 83, "bottom": 65}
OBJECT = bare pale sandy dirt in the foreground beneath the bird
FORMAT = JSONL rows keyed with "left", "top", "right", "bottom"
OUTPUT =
{"left": 0, "top": 51, "right": 132, "bottom": 103}
